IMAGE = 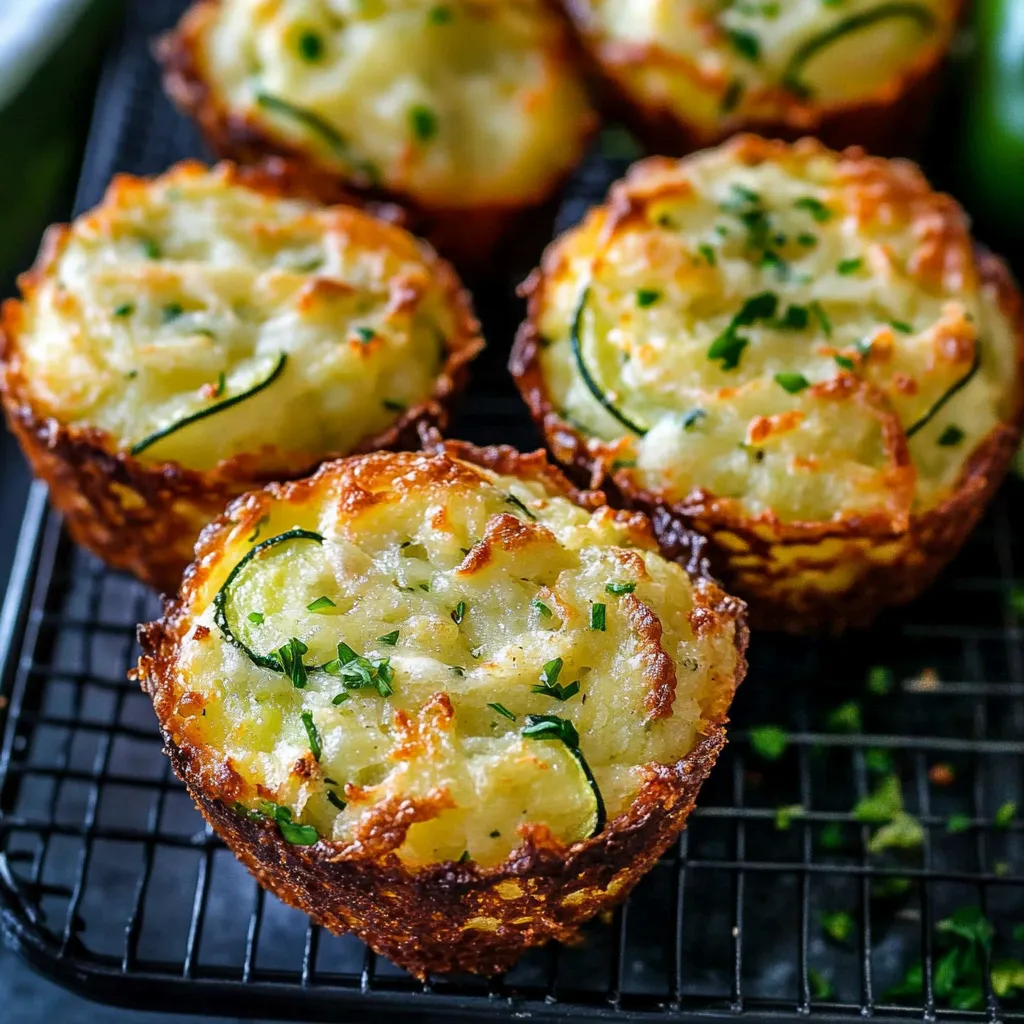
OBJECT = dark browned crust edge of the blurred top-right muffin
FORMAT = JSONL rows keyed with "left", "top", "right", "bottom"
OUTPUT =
{"left": 561, "top": 0, "right": 966, "bottom": 157}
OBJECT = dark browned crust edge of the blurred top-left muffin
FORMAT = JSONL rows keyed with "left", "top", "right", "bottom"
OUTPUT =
{"left": 154, "top": 0, "right": 598, "bottom": 280}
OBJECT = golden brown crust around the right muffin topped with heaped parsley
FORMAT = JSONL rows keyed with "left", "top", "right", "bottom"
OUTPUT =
{"left": 509, "top": 148, "right": 1024, "bottom": 634}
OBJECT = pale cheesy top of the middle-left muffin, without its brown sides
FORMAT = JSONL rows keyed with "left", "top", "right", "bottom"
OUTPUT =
{"left": 11, "top": 164, "right": 480, "bottom": 471}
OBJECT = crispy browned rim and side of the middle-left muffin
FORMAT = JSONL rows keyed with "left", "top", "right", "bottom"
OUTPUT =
{"left": 0, "top": 161, "right": 483, "bottom": 593}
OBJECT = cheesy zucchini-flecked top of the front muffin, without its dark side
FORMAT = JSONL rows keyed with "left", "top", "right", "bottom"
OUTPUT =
{"left": 167, "top": 453, "right": 742, "bottom": 865}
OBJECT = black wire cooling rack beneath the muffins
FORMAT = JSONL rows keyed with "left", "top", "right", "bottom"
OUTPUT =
{"left": 0, "top": 0, "right": 1024, "bottom": 1021}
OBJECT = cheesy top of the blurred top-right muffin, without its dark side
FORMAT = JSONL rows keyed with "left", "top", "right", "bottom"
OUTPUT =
{"left": 566, "top": 0, "right": 959, "bottom": 135}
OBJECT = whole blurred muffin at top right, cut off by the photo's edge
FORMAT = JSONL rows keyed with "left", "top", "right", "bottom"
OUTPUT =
{"left": 563, "top": 0, "right": 963, "bottom": 155}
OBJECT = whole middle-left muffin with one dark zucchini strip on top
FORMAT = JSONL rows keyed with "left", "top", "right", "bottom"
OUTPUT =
{"left": 0, "top": 163, "right": 482, "bottom": 593}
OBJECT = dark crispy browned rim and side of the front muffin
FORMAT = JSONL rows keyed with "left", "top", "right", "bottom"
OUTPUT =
{"left": 136, "top": 435, "right": 749, "bottom": 978}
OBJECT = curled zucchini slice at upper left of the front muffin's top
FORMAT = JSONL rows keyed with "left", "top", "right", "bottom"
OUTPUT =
{"left": 213, "top": 528, "right": 337, "bottom": 672}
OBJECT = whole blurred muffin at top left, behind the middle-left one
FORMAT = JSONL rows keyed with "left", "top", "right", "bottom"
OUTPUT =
{"left": 158, "top": 0, "right": 595, "bottom": 272}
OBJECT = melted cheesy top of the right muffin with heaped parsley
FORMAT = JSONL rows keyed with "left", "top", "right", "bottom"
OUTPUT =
{"left": 538, "top": 137, "right": 1019, "bottom": 524}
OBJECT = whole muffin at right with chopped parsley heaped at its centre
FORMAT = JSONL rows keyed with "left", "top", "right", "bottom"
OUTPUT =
{"left": 512, "top": 136, "right": 1024, "bottom": 632}
